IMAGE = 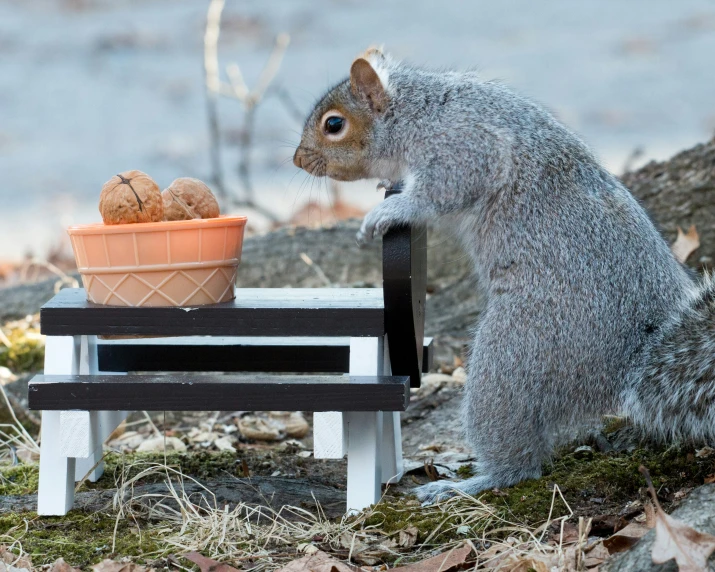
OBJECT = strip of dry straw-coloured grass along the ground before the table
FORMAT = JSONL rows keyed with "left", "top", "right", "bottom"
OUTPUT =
{"left": 107, "top": 463, "right": 588, "bottom": 571}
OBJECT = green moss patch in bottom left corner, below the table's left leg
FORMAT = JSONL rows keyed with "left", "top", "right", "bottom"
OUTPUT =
{"left": 0, "top": 511, "right": 169, "bottom": 568}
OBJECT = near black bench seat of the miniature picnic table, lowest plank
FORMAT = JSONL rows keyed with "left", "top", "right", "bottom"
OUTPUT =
{"left": 28, "top": 374, "right": 410, "bottom": 411}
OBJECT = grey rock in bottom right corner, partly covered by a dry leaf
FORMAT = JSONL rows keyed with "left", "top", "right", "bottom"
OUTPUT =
{"left": 601, "top": 485, "right": 715, "bottom": 572}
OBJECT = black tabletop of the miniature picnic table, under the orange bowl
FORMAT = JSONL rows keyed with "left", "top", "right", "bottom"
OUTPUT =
{"left": 40, "top": 288, "right": 384, "bottom": 336}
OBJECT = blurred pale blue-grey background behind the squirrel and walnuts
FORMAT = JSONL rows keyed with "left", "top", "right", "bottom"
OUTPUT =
{"left": 0, "top": 0, "right": 715, "bottom": 274}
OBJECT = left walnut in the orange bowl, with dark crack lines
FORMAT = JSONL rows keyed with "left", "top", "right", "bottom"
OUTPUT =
{"left": 99, "top": 171, "right": 164, "bottom": 224}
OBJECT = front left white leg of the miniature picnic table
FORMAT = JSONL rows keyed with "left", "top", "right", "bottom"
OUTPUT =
{"left": 37, "top": 336, "right": 80, "bottom": 515}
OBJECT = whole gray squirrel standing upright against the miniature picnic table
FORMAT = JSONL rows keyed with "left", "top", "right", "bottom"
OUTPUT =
{"left": 293, "top": 49, "right": 715, "bottom": 502}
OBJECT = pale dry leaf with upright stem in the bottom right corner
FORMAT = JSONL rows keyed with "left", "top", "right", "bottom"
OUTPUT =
{"left": 639, "top": 466, "right": 715, "bottom": 572}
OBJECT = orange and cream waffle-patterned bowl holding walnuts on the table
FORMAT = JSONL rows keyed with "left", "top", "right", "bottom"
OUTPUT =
{"left": 67, "top": 216, "right": 246, "bottom": 306}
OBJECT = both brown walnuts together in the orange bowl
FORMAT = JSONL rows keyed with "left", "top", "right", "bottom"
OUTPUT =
{"left": 99, "top": 171, "right": 220, "bottom": 224}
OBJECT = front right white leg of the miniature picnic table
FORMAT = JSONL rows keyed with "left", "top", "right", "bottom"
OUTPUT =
{"left": 345, "top": 338, "right": 384, "bottom": 511}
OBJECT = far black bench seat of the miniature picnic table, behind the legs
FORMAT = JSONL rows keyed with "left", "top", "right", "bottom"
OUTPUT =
{"left": 97, "top": 338, "right": 433, "bottom": 373}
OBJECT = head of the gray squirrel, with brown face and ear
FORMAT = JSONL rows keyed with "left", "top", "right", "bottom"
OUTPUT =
{"left": 293, "top": 48, "right": 389, "bottom": 181}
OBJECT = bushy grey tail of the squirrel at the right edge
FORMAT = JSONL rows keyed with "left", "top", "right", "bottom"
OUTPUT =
{"left": 624, "top": 276, "right": 715, "bottom": 441}
